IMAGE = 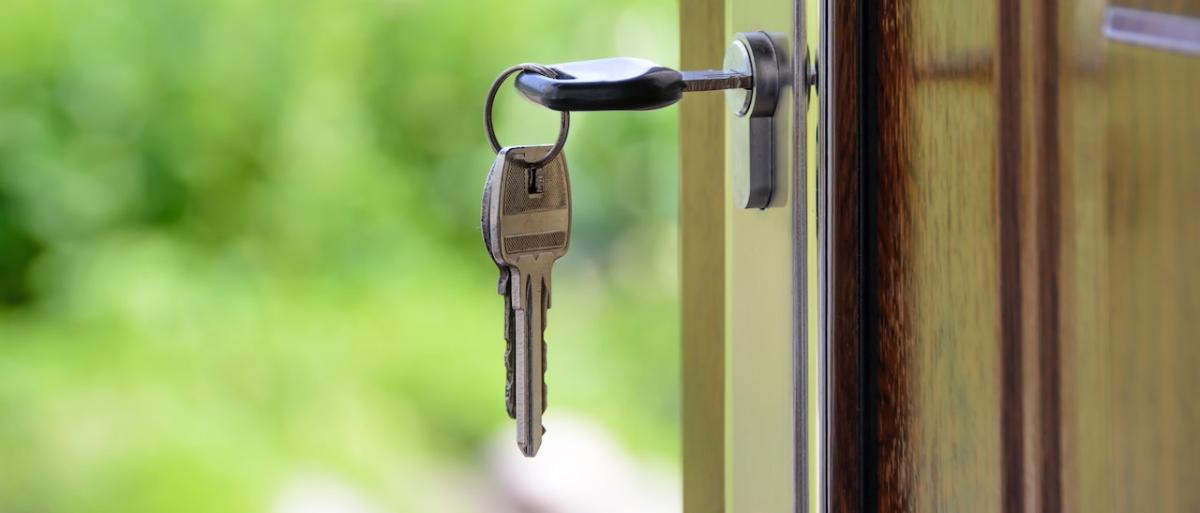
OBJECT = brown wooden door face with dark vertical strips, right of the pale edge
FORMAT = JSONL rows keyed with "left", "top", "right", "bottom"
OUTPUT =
{"left": 821, "top": 0, "right": 1200, "bottom": 512}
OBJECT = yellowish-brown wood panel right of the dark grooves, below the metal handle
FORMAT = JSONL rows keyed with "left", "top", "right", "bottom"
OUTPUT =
{"left": 1060, "top": 0, "right": 1200, "bottom": 512}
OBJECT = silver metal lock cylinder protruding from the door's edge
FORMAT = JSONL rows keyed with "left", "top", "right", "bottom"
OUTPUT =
{"left": 725, "top": 32, "right": 787, "bottom": 209}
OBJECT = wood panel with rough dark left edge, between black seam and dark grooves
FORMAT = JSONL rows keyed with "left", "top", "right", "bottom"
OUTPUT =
{"left": 878, "top": 0, "right": 1021, "bottom": 512}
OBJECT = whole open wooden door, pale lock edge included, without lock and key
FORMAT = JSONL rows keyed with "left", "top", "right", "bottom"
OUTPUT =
{"left": 680, "top": 0, "right": 1200, "bottom": 512}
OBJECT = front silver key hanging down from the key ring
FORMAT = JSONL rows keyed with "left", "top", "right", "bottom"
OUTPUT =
{"left": 490, "top": 146, "right": 571, "bottom": 457}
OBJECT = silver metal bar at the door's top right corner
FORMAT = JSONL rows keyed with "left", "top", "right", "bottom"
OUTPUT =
{"left": 1104, "top": 7, "right": 1200, "bottom": 55}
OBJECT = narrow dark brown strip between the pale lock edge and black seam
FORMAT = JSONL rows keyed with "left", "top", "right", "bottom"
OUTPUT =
{"left": 818, "top": 1, "right": 866, "bottom": 513}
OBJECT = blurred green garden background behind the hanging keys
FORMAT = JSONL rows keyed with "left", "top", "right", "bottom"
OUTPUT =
{"left": 0, "top": 0, "right": 679, "bottom": 513}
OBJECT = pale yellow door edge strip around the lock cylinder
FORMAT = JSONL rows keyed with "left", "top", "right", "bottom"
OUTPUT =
{"left": 679, "top": 0, "right": 823, "bottom": 513}
